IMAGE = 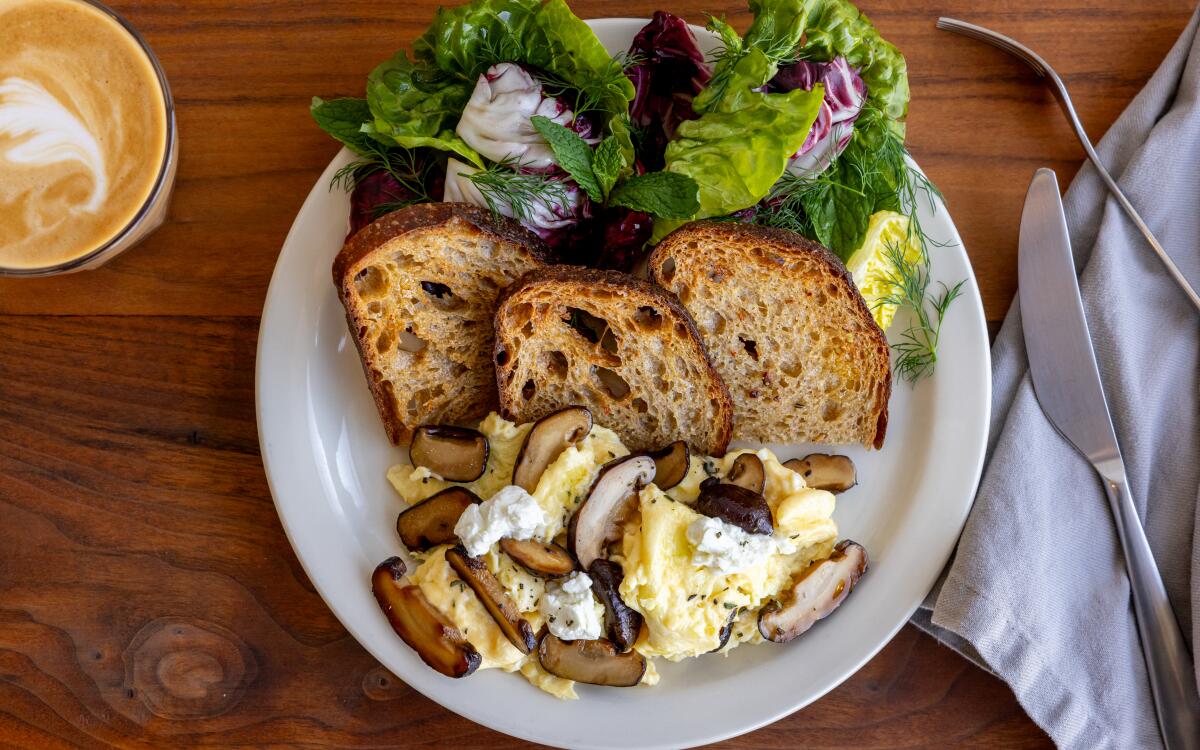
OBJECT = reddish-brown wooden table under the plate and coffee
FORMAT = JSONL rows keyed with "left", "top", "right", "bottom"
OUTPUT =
{"left": 0, "top": 0, "right": 1192, "bottom": 748}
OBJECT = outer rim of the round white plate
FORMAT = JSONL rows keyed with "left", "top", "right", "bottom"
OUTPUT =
{"left": 254, "top": 17, "right": 992, "bottom": 750}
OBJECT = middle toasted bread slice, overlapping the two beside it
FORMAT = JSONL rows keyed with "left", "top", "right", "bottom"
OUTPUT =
{"left": 496, "top": 266, "right": 733, "bottom": 456}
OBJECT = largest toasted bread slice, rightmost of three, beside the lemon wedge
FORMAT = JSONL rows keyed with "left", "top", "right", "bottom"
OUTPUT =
{"left": 649, "top": 221, "right": 892, "bottom": 449}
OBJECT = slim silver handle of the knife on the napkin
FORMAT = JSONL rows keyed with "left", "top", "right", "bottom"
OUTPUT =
{"left": 1102, "top": 472, "right": 1200, "bottom": 750}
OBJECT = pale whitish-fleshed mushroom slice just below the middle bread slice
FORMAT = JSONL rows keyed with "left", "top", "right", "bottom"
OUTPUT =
{"left": 566, "top": 455, "right": 654, "bottom": 570}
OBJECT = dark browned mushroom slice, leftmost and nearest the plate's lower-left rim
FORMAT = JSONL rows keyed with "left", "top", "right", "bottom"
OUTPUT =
{"left": 371, "top": 557, "right": 482, "bottom": 677}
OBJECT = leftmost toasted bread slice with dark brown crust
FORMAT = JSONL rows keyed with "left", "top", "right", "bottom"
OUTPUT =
{"left": 334, "top": 203, "right": 550, "bottom": 445}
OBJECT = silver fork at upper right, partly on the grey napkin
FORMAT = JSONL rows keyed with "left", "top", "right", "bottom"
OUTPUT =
{"left": 937, "top": 17, "right": 1200, "bottom": 311}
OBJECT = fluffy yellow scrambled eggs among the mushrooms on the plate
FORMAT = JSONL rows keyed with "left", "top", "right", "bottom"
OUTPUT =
{"left": 388, "top": 414, "right": 838, "bottom": 698}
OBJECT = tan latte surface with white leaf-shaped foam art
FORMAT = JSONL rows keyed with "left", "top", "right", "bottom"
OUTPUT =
{"left": 0, "top": 0, "right": 168, "bottom": 270}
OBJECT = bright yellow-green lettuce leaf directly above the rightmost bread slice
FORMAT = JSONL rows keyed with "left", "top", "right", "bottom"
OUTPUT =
{"left": 654, "top": 48, "right": 824, "bottom": 241}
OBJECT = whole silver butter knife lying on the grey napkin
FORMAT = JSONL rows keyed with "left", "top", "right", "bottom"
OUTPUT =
{"left": 1018, "top": 169, "right": 1200, "bottom": 750}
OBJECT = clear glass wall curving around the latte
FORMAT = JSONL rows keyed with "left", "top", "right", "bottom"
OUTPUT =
{"left": 0, "top": 0, "right": 179, "bottom": 276}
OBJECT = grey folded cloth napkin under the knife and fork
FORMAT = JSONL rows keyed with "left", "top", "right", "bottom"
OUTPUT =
{"left": 913, "top": 11, "right": 1200, "bottom": 750}
